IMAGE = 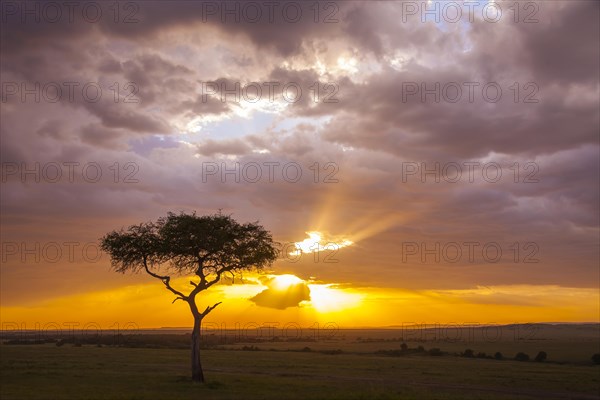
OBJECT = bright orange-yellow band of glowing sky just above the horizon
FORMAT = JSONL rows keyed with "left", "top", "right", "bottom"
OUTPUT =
{"left": 0, "top": 280, "right": 600, "bottom": 329}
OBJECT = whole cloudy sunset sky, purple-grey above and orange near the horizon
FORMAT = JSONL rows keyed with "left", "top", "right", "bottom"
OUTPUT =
{"left": 0, "top": 0, "right": 600, "bottom": 329}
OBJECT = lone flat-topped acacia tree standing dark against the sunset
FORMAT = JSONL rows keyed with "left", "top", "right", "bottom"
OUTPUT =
{"left": 100, "top": 213, "right": 277, "bottom": 382}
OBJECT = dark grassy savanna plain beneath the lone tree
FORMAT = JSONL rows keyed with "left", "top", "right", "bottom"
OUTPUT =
{"left": 0, "top": 326, "right": 600, "bottom": 400}
